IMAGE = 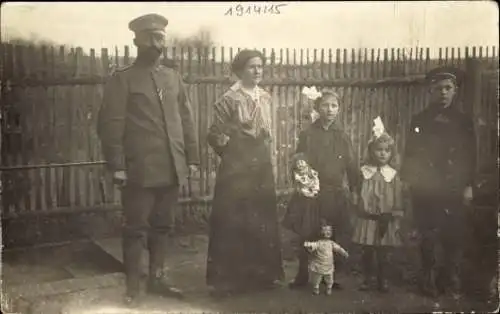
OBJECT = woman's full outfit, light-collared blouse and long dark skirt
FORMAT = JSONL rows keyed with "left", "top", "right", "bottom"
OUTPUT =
{"left": 206, "top": 82, "right": 283, "bottom": 290}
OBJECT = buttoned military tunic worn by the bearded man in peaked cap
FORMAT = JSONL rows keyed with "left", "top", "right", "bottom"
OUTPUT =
{"left": 98, "top": 63, "right": 199, "bottom": 187}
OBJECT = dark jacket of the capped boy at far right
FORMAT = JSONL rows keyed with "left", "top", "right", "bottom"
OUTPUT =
{"left": 401, "top": 104, "right": 476, "bottom": 195}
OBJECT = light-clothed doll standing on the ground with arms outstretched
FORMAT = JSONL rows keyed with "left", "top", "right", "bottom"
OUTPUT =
{"left": 304, "top": 225, "right": 349, "bottom": 295}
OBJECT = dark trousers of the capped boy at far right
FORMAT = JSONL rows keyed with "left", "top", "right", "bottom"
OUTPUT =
{"left": 413, "top": 195, "right": 468, "bottom": 292}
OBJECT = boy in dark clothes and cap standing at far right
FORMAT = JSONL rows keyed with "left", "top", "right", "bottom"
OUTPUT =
{"left": 401, "top": 67, "right": 476, "bottom": 299}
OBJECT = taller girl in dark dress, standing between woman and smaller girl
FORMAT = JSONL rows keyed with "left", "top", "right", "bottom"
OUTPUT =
{"left": 290, "top": 89, "right": 360, "bottom": 288}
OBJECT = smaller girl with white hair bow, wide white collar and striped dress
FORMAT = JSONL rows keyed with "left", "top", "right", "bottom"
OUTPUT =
{"left": 353, "top": 118, "right": 404, "bottom": 292}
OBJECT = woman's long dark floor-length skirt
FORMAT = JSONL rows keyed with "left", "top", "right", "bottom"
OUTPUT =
{"left": 206, "top": 135, "right": 283, "bottom": 289}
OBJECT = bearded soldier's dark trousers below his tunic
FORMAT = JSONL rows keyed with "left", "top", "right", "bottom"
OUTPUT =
{"left": 122, "top": 185, "right": 179, "bottom": 294}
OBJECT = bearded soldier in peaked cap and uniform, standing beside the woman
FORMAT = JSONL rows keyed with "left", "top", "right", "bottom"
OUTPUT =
{"left": 98, "top": 14, "right": 199, "bottom": 303}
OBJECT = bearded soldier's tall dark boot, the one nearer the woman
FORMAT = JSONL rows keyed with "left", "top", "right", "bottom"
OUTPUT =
{"left": 147, "top": 233, "right": 184, "bottom": 299}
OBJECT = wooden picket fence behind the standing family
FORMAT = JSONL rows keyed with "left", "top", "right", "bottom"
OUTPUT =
{"left": 1, "top": 44, "right": 498, "bottom": 217}
